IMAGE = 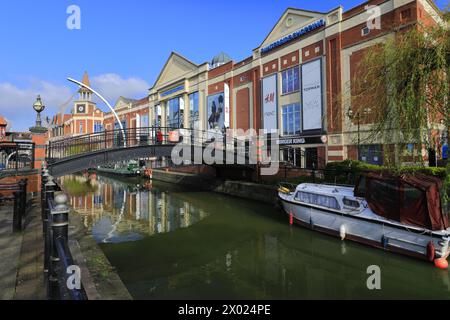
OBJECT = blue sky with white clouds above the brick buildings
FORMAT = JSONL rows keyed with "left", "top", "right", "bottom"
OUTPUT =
{"left": 0, "top": 0, "right": 448, "bottom": 130}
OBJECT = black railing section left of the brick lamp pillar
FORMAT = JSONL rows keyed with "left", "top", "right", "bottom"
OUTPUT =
{"left": 0, "top": 141, "right": 35, "bottom": 172}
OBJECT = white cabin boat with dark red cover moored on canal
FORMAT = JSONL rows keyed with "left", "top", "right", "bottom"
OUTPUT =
{"left": 278, "top": 175, "right": 450, "bottom": 261}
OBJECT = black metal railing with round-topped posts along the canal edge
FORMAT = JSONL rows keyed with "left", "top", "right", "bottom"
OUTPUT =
{"left": 41, "top": 166, "right": 87, "bottom": 300}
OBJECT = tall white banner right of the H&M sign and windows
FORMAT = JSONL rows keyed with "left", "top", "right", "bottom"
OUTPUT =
{"left": 302, "top": 59, "right": 323, "bottom": 131}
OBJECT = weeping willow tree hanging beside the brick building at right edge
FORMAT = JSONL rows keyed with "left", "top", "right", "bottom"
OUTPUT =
{"left": 344, "top": 13, "right": 450, "bottom": 165}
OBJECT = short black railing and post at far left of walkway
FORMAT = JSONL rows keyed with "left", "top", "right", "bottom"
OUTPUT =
{"left": 0, "top": 179, "right": 28, "bottom": 232}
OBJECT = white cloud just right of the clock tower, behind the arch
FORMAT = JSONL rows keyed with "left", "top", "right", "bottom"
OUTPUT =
{"left": 91, "top": 73, "right": 150, "bottom": 104}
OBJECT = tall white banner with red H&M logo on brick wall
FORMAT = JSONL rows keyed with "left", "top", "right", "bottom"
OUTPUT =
{"left": 262, "top": 74, "right": 278, "bottom": 132}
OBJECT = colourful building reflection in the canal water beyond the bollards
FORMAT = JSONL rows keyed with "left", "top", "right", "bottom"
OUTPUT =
{"left": 61, "top": 175, "right": 208, "bottom": 243}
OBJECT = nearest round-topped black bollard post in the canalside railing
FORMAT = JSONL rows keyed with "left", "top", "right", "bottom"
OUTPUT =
{"left": 49, "top": 194, "right": 69, "bottom": 300}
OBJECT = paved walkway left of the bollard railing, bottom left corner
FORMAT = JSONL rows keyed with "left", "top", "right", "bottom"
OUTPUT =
{"left": 0, "top": 199, "right": 45, "bottom": 300}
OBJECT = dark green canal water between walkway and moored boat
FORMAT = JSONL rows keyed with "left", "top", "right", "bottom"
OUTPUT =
{"left": 62, "top": 175, "right": 450, "bottom": 299}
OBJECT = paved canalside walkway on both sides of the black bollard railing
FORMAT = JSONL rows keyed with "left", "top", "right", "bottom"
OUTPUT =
{"left": 0, "top": 198, "right": 132, "bottom": 300}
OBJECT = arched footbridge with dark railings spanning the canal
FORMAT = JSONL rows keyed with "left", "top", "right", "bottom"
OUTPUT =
{"left": 46, "top": 127, "right": 256, "bottom": 177}
